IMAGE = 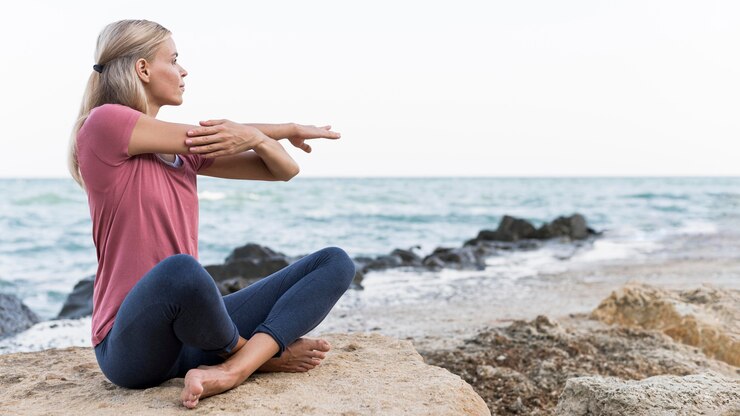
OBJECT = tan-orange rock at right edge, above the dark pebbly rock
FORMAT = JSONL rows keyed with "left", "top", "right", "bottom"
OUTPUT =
{"left": 591, "top": 282, "right": 740, "bottom": 366}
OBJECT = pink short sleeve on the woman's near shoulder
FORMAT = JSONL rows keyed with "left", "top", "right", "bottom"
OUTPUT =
{"left": 80, "top": 104, "right": 141, "bottom": 166}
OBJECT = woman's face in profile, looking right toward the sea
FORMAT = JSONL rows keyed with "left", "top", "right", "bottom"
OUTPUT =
{"left": 145, "top": 38, "right": 188, "bottom": 107}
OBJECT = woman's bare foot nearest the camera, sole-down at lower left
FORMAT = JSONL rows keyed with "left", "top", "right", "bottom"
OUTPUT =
{"left": 180, "top": 365, "right": 238, "bottom": 409}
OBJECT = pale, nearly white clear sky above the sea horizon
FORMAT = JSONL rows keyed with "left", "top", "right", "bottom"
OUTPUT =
{"left": 0, "top": 0, "right": 740, "bottom": 177}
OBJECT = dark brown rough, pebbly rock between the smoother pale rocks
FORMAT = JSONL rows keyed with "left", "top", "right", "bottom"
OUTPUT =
{"left": 423, "top": 316, "right": 737, "bottom": 415}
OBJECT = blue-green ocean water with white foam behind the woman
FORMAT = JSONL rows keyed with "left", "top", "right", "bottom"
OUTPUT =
{"left": 0, "top": 178, "right": 740, "bottom": 352}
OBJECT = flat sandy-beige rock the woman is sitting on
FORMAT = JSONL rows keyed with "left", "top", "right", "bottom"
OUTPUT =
{"left": 0, "top": 334, "right": 490, "bottom": 416}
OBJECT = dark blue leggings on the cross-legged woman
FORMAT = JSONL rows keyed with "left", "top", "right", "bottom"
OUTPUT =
{"left": 95, "top": 247, "right": 355, "bottom": 388}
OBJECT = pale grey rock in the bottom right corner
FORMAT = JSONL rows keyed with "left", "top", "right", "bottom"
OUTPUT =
{"left": 555, "top": 373, "right": 740, "bottom": 416}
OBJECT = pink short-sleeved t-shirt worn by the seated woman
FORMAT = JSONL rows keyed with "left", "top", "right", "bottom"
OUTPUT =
{"left": 77, "top": 104, "right": 213, "bottom": 346}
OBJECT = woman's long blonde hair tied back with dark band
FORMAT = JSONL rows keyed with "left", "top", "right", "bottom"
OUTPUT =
{"left": 67, "top": 20, "right": 171, "bottom": 189}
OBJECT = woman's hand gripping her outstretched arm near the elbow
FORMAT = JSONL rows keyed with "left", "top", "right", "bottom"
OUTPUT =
{"left": 185, "top": 120, "right": 268, "bottom": 158}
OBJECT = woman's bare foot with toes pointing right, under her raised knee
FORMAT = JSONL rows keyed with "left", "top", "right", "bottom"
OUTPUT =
{"left": 258, "top": 338, "right": 331, "bottom": 373}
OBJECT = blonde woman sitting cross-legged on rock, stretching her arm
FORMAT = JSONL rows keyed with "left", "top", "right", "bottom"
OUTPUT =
{"left": 70, "top": 20, "right": 354, "bottom": 408}
